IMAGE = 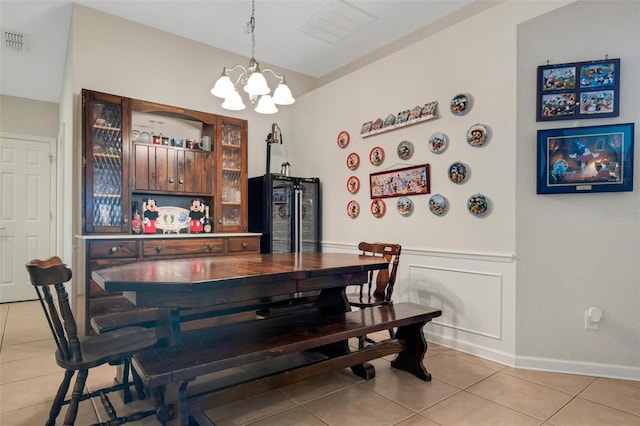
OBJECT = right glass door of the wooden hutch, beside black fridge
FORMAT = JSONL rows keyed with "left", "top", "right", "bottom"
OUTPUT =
{"left": 216, "top": 117, "right": 247, "bottom": 231}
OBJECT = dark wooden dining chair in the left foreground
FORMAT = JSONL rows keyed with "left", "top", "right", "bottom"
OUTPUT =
{"left": 26, "top": 256, "right": 157, "bottom": 426}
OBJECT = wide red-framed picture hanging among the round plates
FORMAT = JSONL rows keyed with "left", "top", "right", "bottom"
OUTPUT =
{"left": 369, "top": 164, "right": 431, "bottom": 200}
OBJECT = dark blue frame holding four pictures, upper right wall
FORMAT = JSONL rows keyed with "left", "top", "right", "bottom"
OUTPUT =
{"left": 536, "top": 58, "right": 620, "bottom": 121}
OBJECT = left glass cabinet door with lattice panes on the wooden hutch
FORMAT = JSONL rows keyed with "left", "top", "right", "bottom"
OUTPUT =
{"left": 83, "top": 92, "right": 131, "bottom": 233}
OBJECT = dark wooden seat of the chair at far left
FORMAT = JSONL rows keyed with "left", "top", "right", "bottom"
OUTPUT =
{"left": 56, "top": 327, "right": 157, "bottom": 371}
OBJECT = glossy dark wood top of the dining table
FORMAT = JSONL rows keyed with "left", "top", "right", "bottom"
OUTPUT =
{"left": 92, "top": 253, "right": 387, "bottom": 292}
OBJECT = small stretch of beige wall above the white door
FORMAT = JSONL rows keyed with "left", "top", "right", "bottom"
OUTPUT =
{"left": 0, "top": 95, "right": 58, "bottom": 138}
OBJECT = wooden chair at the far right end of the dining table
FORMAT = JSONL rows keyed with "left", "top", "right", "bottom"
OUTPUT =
{"left": 347, "top": 241, "right": 402, "bottom": 348}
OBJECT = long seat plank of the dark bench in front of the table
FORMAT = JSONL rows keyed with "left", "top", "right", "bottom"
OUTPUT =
{"left": 134, "top": 303, "right": 442, "bottom": 387}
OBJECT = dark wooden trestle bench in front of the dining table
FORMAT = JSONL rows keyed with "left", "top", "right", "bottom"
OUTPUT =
{"left": 132, "top": 303, "right": 442, "bottom": 425}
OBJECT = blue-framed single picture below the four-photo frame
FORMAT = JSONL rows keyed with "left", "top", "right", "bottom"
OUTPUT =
{"left": 536, "top": 123, "right": 634, "bottom": 194}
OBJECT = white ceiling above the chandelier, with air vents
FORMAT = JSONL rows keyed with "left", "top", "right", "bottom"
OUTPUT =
{"left": 0, "top": 0, "right": 473, "bottom": 102}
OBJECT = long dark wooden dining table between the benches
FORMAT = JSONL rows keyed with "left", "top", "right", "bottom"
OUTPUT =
{"left": 92, "top": 253, "right": 388, "bottom": 345}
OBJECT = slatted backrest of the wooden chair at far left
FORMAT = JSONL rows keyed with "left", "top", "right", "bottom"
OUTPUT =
{"left": 25, "top": 256, "right": 82, "bottom": 362}
